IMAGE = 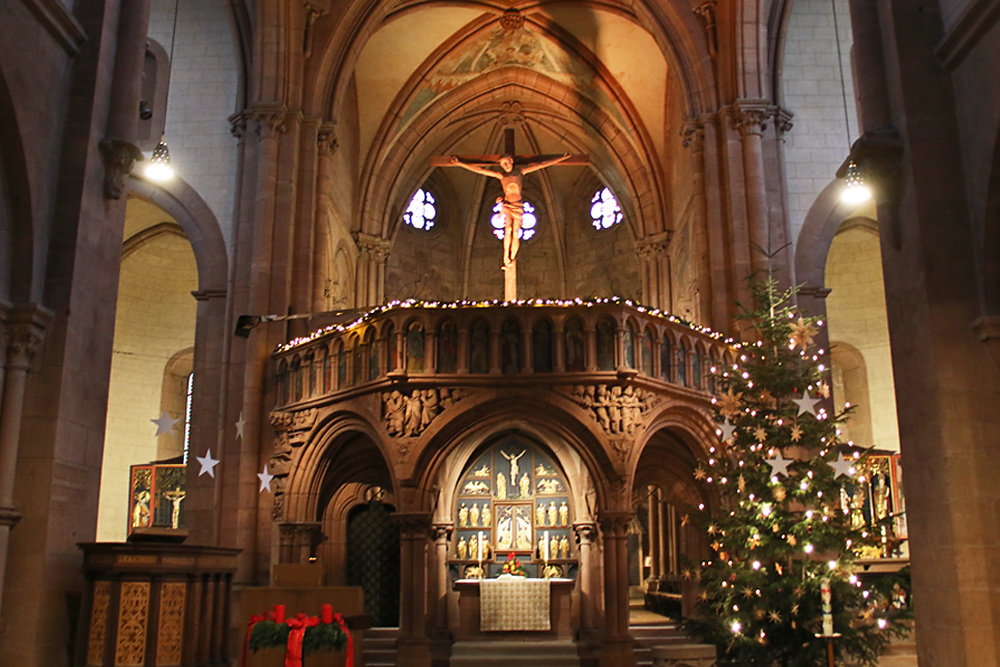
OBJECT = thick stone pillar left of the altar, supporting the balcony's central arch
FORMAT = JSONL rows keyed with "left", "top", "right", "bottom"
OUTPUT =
{"left": 393, "top": 512, "right": 431, "bottom": 667}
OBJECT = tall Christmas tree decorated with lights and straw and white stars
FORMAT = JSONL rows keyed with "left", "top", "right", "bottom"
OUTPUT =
{"left": 683, "top": 281, "right": 908, "bottom": 667}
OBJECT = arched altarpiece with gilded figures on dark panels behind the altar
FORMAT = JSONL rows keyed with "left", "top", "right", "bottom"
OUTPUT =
{"left": 449, "top": 438, "right": 577, "bottom": 578}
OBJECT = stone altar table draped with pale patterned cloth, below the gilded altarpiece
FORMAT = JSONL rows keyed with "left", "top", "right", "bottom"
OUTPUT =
{"left": 455, "top": 578, "right": 575, "bottom": 640}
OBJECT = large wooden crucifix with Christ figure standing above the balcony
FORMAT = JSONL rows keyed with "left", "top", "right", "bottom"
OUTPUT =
{"left": 431, "top": 128, "right": 590, "bottom": 301}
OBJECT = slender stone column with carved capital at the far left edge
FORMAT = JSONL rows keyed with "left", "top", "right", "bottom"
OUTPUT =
{"left": 0, "top": 305, "right": 52, "bottom": 622}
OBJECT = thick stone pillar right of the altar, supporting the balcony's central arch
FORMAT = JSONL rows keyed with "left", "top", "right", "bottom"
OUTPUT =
{"left": 599, "top": 511, "right": 635, "bottom": 667}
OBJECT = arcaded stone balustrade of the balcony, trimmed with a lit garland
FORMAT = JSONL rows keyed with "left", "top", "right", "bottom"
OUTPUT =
{"left": 274, "top": 299, "right": 734, "bottom": 408}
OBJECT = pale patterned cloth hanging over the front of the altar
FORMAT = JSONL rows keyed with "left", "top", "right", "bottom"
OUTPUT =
{"left": 479, "top": 577, "right": 551, "bottom": 632}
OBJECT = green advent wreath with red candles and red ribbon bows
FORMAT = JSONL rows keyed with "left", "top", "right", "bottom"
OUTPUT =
{"left": 243, "top": 604, "right": 354, "bottom": 667}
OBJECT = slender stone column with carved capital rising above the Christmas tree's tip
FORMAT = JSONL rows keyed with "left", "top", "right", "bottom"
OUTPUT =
{"left": 735, "top": 100, "right": 771, "bottom": 278}
